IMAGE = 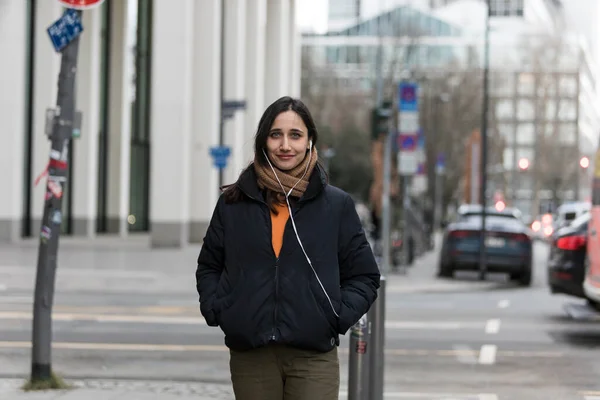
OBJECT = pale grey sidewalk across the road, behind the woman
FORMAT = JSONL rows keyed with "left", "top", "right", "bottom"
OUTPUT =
{"left": 0, "top": 235, "right": 498, "bottom": 296}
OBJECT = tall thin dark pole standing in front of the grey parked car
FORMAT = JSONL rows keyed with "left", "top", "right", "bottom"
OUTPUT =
{"left": 479, "top": 0, "right": 491, "bottom": 280}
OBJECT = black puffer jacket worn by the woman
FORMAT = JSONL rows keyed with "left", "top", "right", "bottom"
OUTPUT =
{"left": 196, "top": 167, "right": 380, "bottom": 351}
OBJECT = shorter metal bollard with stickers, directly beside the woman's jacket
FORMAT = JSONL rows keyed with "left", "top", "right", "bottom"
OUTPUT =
{"left": 348, "top": 314, "right": 370, "bottom": 400}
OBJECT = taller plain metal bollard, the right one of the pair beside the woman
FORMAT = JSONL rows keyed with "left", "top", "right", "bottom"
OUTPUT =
{"left": 367, "top": 275, "right": 386, "bottom": 400}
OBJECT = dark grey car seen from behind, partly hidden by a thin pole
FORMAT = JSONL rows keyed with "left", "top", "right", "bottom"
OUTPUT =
{"left": 438, "top": 207, "right": 533, "bottom": 286}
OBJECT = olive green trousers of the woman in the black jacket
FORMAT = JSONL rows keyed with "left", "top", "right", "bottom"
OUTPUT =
{"left": 229, "top": 345, "right": 340, "bottom": 400}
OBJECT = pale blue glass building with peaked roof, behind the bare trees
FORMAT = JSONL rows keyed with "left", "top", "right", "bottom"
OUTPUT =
{"left": 302, "top": 6, "right": 474, "bottom": 92}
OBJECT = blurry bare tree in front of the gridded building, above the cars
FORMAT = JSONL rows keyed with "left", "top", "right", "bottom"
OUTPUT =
{"left": 525, "top": 35, "right": 580, "bottom": 213}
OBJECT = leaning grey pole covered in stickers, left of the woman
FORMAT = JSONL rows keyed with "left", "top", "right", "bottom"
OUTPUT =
{"left": 31, "top": 7, "right": 82, "bottom": 382}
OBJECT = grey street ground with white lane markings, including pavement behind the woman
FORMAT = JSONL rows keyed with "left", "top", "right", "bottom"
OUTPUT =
{"left": 0, "top": 236, "right": 600, "bottom": 400}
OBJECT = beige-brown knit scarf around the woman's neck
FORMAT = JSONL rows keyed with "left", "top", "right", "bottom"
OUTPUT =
{"left": 254, "top": 146, "right": 319, "bottom": 198}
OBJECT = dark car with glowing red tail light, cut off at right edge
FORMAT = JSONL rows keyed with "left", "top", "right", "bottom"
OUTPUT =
{"left": 548, "top": 213, "right": 590, "bottom": 298}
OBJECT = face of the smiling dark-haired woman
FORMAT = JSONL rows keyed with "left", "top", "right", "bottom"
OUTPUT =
{"left": 267, "top": 110, "right": 308, "bottom": 171}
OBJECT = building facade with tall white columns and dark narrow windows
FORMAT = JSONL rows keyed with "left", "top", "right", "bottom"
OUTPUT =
{"left": 0, "top": 0, "right": 300, "bottom": 246}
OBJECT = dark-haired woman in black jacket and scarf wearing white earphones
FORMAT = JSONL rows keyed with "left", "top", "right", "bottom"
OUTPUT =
{"left": 196, "top": 97, "right": 379, "bottom": 400}
